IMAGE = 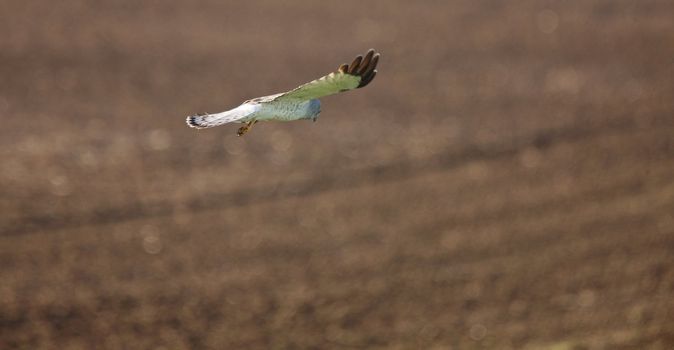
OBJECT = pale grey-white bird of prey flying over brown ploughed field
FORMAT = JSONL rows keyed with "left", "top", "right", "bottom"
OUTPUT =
{"left": 187, "top": 49, "right": 379, "bottom": 136}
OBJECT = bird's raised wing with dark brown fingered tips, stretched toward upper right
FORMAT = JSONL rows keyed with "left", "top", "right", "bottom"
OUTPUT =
{"left": 274, "top": 49, "right": 379, "bottom": 101}
